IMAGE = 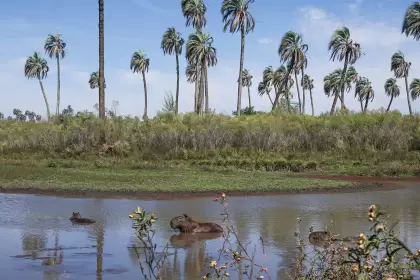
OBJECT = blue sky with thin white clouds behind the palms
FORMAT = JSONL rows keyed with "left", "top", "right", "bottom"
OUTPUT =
{"left": 0, "top": 0, "right": 420, "bottom": 116}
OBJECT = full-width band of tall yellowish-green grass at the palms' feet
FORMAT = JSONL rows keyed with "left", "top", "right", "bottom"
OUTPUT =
{"left": 0, "top": 112, "right": 420, "bottom": 160}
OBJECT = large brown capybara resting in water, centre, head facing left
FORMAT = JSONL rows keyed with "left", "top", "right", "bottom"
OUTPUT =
{"left": 170, "top": 214, "right": 223, "bottom": 233}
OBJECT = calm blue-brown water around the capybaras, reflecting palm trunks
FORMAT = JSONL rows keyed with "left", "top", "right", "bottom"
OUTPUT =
{"left": 0, "top": 183, "right": 420, "bottom": 280}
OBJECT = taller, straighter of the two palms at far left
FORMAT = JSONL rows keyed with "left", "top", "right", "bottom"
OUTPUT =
{"left": 44, "top": 34, "right": 66, "bottom": 116}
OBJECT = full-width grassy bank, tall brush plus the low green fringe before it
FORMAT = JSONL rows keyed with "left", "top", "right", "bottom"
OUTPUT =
{"left": 0, "top": 112, "right": 420, "bottom": 176}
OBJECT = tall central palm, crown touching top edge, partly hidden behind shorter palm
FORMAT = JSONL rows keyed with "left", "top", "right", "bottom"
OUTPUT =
{"left": 181, "top": 0, "right": 207, "bottom": 114}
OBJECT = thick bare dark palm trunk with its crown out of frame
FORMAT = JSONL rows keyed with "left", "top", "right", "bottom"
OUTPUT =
{"left": 98, "top": 0, "right": 105, "bottom": 119}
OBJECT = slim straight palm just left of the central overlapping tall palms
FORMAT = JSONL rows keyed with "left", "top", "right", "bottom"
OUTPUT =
{"left": 160, "top": 27, "right": 185, "bottom": 115}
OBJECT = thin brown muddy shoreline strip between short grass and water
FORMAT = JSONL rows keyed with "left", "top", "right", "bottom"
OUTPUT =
{"left": 0, "top": 180, "right": 404, "bottom": 200}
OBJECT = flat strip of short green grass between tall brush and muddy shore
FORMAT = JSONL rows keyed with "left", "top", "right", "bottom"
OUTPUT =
{"left": 0, "top": 162, "right": 390, "bottom": 199}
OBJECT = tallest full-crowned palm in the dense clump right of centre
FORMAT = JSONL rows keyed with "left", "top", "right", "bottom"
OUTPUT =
{"left": 278, "top": 31, "right": 308, "bottom": 113}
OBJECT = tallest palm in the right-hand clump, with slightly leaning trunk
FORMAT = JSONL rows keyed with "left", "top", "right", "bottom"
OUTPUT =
{"left": 328, "top": 26, "right": 362, "bottom": 113}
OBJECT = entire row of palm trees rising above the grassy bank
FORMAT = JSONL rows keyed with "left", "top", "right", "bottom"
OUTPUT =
{"left": 25, "top": 0, "right": 420, "bottom": 119}
